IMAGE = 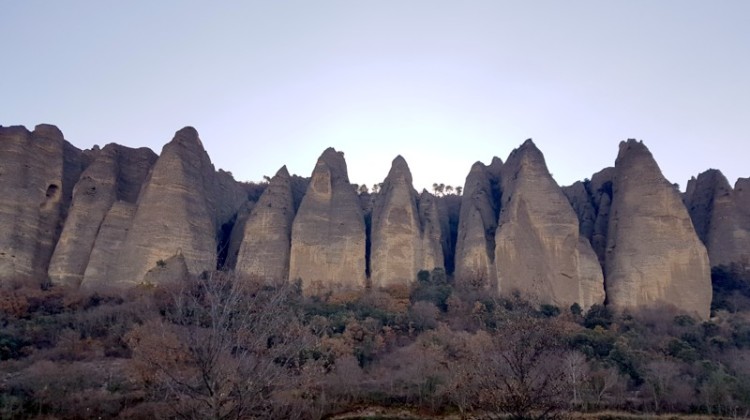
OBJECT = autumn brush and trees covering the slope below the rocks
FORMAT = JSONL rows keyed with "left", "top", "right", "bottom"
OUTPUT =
{"left": 0, "top": 267, "right": 750, "bottom": 418}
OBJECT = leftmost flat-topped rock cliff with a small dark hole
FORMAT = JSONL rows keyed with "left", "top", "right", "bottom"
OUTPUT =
{"left": 0, "top": 124, "right": 86, "bottom": 282}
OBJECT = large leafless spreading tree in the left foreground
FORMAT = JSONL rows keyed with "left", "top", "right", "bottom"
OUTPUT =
{"left": 127, "top": 273, "right": 310, "bottom": 419}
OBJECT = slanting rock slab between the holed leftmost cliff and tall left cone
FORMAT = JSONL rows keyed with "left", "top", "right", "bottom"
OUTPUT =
{"left": 49, "top": 144, "right": 156, "bottom": 287}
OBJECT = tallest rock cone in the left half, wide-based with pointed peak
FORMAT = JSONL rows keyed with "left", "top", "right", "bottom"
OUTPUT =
{"left": 89, "top": 127, "right": 245, "bottom": 287}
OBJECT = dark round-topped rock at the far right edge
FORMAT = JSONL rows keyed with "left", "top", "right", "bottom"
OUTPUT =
{"left": 684, "top": 169, "right": 750, "bottom": 266}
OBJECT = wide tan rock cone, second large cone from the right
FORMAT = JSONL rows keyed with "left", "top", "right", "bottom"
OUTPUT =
{"left": 495, "top": 140, "right": 604, "bottom": 307}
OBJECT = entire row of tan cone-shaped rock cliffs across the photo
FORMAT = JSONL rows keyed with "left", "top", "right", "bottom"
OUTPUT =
{"left": 0, "top": 125, "right": 728, "bottom": 317}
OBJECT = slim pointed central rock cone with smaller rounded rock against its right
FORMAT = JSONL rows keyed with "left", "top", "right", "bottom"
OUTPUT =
{"left": 370, "top": 156, "right": 443, "bottom": 287}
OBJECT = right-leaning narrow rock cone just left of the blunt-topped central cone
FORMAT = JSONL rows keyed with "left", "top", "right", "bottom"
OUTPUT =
{"left": 235, "top": 166, "right": 294, "bottom": 283}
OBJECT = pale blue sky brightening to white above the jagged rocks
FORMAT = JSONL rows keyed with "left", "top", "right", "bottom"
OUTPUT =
{"left": 0, "top": 0, "right": 750, "bottom": 190}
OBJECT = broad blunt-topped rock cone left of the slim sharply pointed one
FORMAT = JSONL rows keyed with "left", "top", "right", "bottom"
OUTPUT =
{"left": 289, "top": 148, "right": 365, "bottom": 294}
